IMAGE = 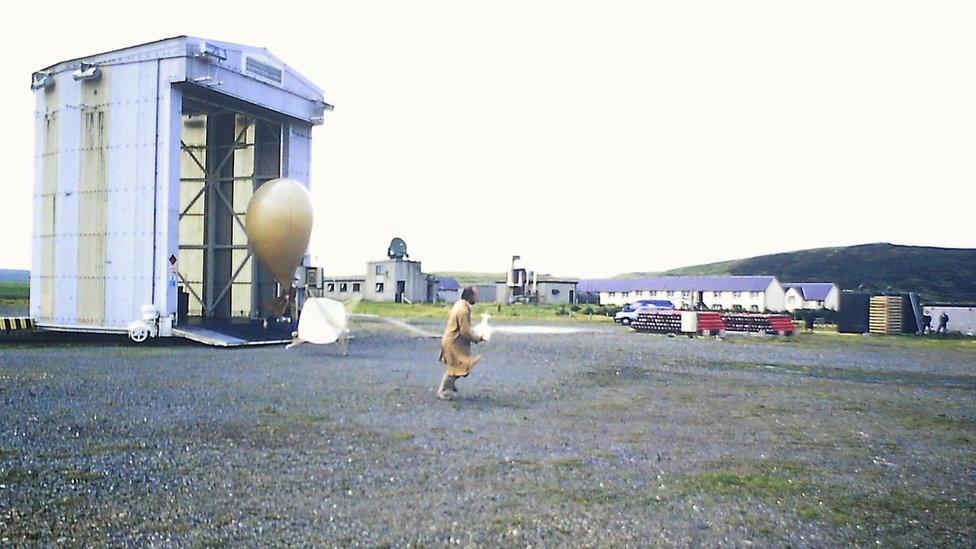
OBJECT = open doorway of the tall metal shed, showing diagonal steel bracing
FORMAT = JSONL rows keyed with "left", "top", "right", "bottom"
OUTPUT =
{"left": 178, "top": 97, "right": 283, "bottom": 323}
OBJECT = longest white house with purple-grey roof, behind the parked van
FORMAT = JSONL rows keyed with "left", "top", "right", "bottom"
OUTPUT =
{"left": 578, "top": 276, "right": 785, "bottom": 312}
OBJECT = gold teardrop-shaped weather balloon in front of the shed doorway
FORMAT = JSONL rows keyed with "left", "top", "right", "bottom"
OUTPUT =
{"left": 245, "top": 179, "right": 312, "bottom": 288}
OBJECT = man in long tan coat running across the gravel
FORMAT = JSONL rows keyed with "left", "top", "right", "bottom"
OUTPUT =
{"left": 437, "top": 286, "right": 484, "bottom": 400}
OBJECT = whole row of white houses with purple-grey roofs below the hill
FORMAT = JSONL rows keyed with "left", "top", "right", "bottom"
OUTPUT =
{"left": 578, "top": 276, "right": 840, "bottom": 312}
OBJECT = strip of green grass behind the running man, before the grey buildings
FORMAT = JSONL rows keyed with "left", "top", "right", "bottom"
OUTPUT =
{"left": 356, "top": 301, "right": 613, "bottom": 322}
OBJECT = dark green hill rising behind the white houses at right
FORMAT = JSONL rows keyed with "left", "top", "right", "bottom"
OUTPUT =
{"left": 621, "top": 243, "right": 976, "bottom": 303}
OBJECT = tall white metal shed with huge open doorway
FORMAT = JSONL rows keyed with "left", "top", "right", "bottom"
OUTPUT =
{"left": 30, "top": 36, "right": 331, "bottom": 342}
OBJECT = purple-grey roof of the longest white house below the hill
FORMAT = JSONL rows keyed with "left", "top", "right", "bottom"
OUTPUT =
{"left": 579, "top": 276, "right": 776, "bottom": 292}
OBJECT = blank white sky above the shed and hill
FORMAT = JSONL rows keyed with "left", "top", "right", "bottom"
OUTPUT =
{"left": 0, "top": 0, "right": 976, "bottom": 277}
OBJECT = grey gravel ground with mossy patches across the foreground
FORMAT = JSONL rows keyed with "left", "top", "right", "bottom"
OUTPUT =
{"left": 0, "top": 324, "right": 976, "bottom": 546}
